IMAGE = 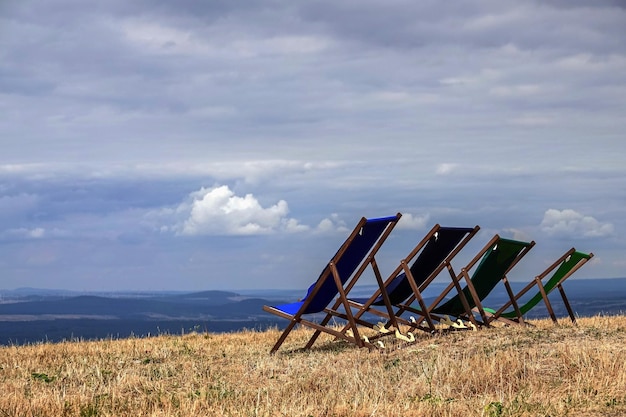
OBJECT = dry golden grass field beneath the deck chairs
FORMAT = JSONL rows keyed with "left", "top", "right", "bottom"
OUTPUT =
{"left": 0, "top": 316, "right": 626, "bottom": 417}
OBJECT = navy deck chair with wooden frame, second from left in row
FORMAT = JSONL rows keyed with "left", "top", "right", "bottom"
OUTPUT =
{"left": 349, "top": 224, "right": 480, "bottom": 334}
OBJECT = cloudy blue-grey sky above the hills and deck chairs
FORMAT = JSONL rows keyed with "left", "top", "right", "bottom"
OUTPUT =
{"left": 0, "top": 0, "right": 626, "bottom": 291}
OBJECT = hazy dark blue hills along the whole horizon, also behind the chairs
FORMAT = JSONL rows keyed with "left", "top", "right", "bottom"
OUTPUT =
{"left": 0, "top": 278, "right": 626, "bottom": 345}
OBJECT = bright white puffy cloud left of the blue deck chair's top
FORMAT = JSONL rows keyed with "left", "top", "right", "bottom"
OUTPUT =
{"left": 176, "top": 185, "right": 309, "bottom": 236}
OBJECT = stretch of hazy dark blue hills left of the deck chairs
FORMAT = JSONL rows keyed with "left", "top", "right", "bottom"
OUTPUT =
{"left": 0, "top": 290, "right": 281, "bottom": 345}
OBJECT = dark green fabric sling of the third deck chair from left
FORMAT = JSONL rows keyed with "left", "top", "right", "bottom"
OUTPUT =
{"left": 433, "top": 238, "right": 531, "bottom": 316}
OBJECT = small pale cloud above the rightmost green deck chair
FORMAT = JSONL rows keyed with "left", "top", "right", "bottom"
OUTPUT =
{"left": 540, "top": 209, "right": 613, "bottom": 238}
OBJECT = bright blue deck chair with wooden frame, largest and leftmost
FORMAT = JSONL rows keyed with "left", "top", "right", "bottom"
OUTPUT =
{"left": 263, "top": 213, "right": 401, "bottom": 353}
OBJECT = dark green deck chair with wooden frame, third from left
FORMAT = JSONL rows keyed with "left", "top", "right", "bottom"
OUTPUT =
{"left": 397, "top": 235, "right": 535, "bottom": 326}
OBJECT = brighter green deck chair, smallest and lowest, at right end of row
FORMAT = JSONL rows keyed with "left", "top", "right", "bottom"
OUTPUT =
{"left": 485, "top": 248, "right": 593, "bottom": 324}
